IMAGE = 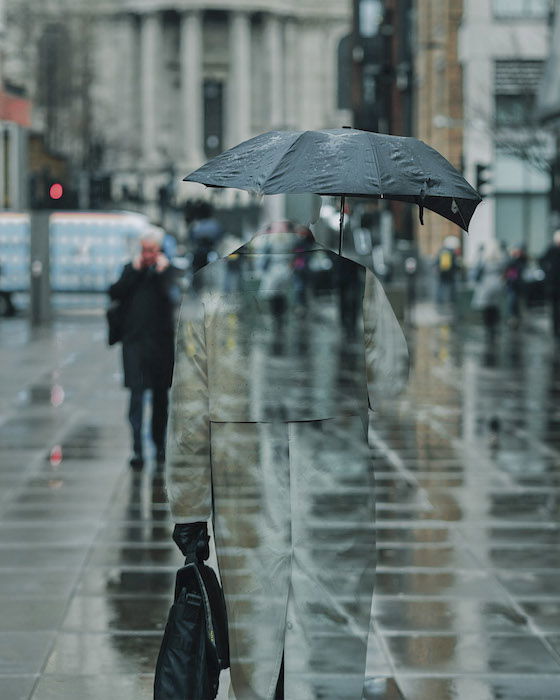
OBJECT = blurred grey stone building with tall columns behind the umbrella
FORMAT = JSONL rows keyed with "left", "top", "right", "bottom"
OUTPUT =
{"left": 4, "top": 0, "right": 351, "bottom": 211}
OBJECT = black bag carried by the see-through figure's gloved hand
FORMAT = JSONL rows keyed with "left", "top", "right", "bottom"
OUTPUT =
{"left": 154, "top": 563, "right": 229, "bottom": 700}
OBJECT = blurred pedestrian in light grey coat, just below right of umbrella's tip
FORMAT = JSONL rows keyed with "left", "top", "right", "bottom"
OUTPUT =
{"left": 472, "top": 239, "right": 506, "bottom": 338}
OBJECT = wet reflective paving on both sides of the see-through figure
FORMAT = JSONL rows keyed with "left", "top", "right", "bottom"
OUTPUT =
{"left": 0, "top": 306, "right": 560, "bottom": 700}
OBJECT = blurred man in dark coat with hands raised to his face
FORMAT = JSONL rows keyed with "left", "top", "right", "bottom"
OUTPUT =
{"left": 109, "top": 226, "right": 174, "bottom": 468}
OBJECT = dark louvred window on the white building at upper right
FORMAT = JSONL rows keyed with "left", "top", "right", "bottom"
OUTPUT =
{"left": 494, "top": 61, "right": 543, "bottom": 127}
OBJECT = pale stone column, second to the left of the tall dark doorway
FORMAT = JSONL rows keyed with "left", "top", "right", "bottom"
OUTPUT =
{"left": 140, "top": 12, "right": 161, "bottom": 167}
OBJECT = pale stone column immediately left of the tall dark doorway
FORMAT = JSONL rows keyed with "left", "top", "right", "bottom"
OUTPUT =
{"left": 180, "top": 10, "right": 205, "bottom": 170}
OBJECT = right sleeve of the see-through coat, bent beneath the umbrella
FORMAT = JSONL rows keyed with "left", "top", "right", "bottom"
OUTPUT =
{"left": 363, "top": 270, "right": 409, "bottom": 408}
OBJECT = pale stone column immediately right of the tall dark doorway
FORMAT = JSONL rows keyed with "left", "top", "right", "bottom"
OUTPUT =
{"left": 226, "top": 12, "right": 252, "bottom": 146}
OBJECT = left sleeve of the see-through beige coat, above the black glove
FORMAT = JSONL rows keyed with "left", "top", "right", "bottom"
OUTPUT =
{"left": 166, "top": 296, "right": 212, "bottom": 523}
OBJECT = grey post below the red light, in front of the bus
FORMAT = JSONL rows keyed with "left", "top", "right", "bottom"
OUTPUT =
{"left": 29, "top": 211, "right": 51, "bottom": 326}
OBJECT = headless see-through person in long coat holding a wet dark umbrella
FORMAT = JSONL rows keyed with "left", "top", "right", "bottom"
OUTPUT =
{"left": 166, "top": 129, "right": 480, "bottom": 700}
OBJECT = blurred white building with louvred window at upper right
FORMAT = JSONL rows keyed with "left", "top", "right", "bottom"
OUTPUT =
{"left": 459, "top": 0, "right": 551, "bottom": 262}
